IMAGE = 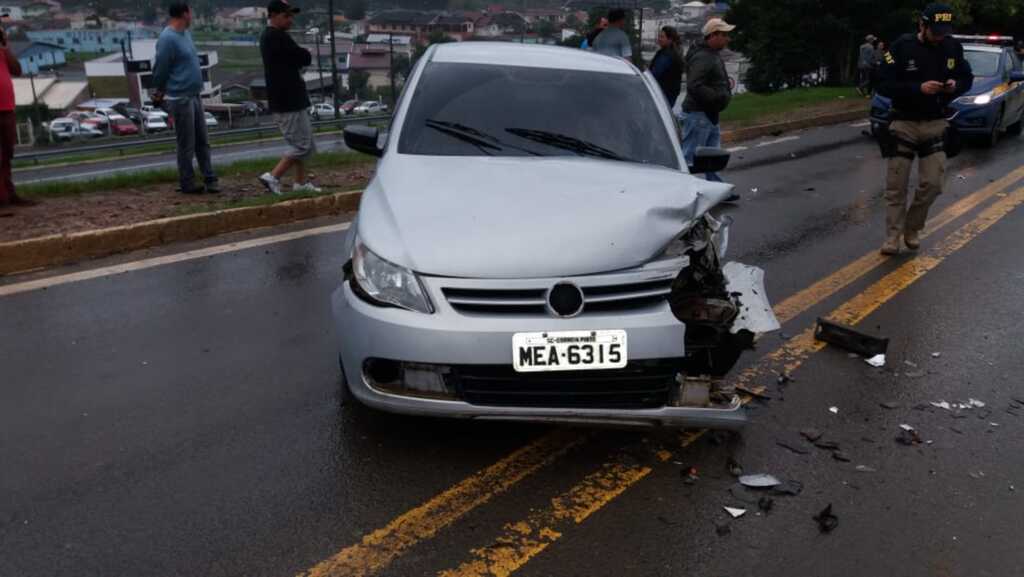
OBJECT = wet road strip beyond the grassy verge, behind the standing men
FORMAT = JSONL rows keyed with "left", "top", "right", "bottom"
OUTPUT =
{"left": 14, "top": 131, "right": 348, "bottom": 184}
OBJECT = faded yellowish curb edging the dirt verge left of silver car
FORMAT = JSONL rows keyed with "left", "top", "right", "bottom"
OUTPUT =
{"left": 0, "top": 192, "right": 362, "bottom": 275}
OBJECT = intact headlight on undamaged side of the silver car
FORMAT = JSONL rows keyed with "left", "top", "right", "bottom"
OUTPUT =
{"left": 352, "top": 240, "right": 434, "bottom": 315}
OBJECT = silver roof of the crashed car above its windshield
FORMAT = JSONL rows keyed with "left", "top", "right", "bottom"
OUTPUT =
{"left": 431, "top": 42, "right": 637, "bottom": 75}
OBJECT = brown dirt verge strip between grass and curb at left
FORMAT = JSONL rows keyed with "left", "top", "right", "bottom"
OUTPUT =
{"left": 0, "top": 164, "right": 374, "bottom": 242}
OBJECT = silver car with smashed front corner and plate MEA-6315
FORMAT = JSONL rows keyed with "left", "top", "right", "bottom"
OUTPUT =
{"left": 332, "top": 42, "right": 778, "bottom": 428}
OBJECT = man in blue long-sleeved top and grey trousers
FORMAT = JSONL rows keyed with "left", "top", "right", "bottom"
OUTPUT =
{"left": 153, "top": 1, "right": 220, "bottom": 195}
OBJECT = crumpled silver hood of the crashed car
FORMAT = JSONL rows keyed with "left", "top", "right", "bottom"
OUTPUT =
{"left": 358, "top": 155, "right": 732, "bottom": 278}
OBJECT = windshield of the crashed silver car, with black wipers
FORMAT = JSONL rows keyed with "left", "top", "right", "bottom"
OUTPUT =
{"left": 398, "top": 63, "right": 679, "bottom": 169}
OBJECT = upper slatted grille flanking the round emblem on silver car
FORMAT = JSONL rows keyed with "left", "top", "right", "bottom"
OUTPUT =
{"left": 441, "top": 279, "right": 673, "bottom": 316}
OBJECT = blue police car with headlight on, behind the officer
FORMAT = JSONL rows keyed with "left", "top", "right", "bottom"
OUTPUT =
{"left": 871, "top": 35, "right": 1024, "bottom": 146}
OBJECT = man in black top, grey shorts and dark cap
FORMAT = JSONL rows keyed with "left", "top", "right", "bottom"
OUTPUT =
{"left": 259, "top": 0, "right": 322, "bottom": 195}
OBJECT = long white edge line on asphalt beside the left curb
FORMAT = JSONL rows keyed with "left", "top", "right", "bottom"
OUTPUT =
{"left": 0, "top": 222, "right": 351, "bottom": 296}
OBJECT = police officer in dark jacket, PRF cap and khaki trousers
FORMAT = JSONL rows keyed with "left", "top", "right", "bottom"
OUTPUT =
{"left": 879, "top": 3, "right": 974, "bottom": 255}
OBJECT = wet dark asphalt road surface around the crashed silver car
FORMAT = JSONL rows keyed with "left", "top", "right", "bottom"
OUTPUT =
{"left": 0, "top": 119, "right": 1024, "bottom": 577}
